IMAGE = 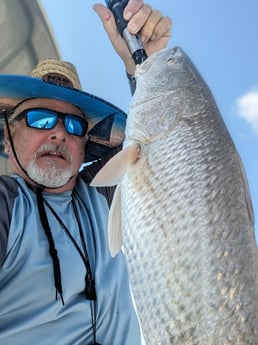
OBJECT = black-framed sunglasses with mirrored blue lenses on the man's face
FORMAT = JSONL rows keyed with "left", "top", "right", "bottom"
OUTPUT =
{"left": 15, "top": 108, "right": 88, "bottom": 137}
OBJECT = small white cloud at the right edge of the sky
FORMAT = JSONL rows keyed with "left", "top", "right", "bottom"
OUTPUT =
{"left": 236, "top": 87, "right": 258, "bottom": 133}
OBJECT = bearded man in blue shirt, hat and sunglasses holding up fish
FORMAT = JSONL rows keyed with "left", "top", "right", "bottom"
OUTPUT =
{"left": 0, "top": 0, "right": 171, "bottom": 345}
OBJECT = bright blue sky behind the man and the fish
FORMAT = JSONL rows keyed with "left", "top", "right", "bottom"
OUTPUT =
{"left": 41, "top": 0, "right": 258, "bottom": 242}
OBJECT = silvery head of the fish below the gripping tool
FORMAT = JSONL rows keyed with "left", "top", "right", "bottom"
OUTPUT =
{"left": 126, "top": 47, "right": 210, "bottom": 144}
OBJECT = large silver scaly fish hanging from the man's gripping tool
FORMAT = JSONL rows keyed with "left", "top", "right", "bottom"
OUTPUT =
{"left": 92, "top": 47, "right": 258, "bottom": 345}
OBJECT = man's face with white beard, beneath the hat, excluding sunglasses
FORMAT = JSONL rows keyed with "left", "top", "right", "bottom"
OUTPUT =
{"left": 5, "top": 99, "right": 86, "bottom": 191}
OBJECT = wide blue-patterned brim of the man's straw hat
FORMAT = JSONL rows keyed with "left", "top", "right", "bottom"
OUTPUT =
{"left": 0, "top": 74, "right": 127, "bottom": 162}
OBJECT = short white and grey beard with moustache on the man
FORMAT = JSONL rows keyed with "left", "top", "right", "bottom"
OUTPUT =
{"left": 27, "top": 144, "right": 73, "bottom": 188}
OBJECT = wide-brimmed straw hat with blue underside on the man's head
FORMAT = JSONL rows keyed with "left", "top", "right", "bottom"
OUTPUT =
{"left": 0, "top": 58, "right": 126, "bottom": 162}
